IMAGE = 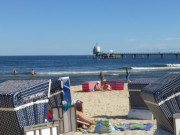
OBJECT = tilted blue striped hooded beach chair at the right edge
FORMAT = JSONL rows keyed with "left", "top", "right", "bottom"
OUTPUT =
{"left": 142, "top": 72, "right": 180, "bottom": 133}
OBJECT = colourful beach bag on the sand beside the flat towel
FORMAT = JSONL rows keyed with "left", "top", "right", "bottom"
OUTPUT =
{"left": 94, "top": 120, "right": 115, "bottom": 134}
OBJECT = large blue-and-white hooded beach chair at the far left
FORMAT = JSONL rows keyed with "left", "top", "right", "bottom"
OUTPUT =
{"left": 0, "top": 80, "right": 51, "bottom": 135}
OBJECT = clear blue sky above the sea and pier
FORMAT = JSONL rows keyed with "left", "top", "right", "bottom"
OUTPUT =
{"left": 0, "top": 0, "right": 180, "bottom": 55}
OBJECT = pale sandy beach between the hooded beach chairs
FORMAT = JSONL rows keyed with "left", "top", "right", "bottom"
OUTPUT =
{"left": 62, "top": 84, "right": 156, "bottom": 135}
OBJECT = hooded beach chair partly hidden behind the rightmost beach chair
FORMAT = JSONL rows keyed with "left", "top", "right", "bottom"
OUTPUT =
{"left": 128, "top": 78, "right": 157, "bottom": 120}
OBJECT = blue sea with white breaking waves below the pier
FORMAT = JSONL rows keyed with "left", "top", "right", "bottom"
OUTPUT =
{"left": 0, "top": 55, "right": 180, "bottom": 85}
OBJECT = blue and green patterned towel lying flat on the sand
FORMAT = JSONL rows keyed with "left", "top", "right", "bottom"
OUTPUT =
{"left": 114, "top": 123, "right": 153, "bottom": 131}
